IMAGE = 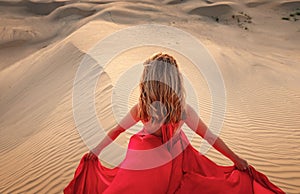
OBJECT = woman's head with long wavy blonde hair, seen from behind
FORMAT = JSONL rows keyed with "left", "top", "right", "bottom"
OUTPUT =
{"left": 139, "top": 53, "right": 185, "bottom": 123}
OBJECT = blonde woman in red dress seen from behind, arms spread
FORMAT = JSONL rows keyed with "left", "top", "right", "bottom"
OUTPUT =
{"left": 64, "top": 53, "right": 284, "bottom": 193}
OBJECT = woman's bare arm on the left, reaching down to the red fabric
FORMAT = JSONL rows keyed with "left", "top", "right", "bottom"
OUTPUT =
{"left": 89, "top": 105, "right": 140, "bottom": 157}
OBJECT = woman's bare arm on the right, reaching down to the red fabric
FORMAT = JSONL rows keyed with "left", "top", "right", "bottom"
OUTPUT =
{"left": 185, "top": 105, "right": 248, "bottom": 170}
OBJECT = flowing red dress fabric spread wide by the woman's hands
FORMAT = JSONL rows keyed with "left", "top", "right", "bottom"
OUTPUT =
{"left": 64, "top": 125, "right": 284, "bottom": 194}
